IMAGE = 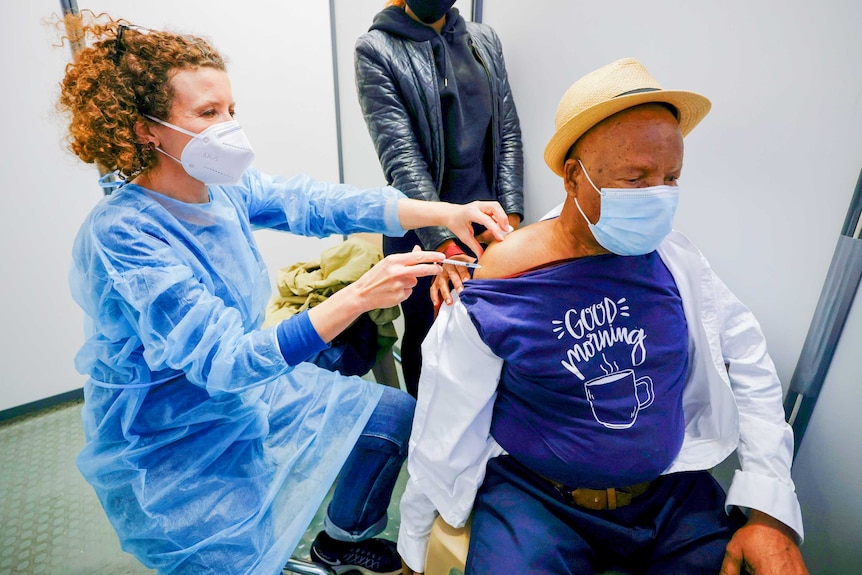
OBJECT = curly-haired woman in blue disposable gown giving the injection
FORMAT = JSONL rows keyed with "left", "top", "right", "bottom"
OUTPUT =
{"left": 58, "top": 11, "right": 507, "bottom": 575}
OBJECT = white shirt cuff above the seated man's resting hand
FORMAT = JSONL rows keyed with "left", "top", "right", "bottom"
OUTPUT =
{"left": 724, "top": 470, "right": 805, "bottom": 544}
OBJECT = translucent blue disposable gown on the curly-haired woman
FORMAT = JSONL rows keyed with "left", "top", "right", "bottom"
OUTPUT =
{"left": 70, "top": 169, "right": 404, "bottom": 575}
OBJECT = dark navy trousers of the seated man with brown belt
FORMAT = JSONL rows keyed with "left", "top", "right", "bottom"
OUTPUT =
{"left": 466, "top": 456, "right": 745, "bottom": 575}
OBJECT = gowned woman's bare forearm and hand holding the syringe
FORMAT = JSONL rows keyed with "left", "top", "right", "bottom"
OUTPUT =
{"left": 308, "top": 247, "right": 443, "bottom": 342}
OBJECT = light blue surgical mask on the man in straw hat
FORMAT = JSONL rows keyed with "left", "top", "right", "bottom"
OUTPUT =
{"left": 575, "top": 160, "right": 679, "bottom": 256}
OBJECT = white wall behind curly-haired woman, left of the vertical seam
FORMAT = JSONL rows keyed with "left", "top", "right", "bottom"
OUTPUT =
{"left": 0, "top": 0, "right": 340, "bottom": 410}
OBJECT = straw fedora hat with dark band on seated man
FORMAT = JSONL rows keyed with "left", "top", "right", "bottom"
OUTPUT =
{"left": 545, "top": 58, "right": 712, "bottom": 176}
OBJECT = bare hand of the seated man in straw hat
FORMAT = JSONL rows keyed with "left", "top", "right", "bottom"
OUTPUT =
{"left": 719, "top": 509, "right": 808, "bottom": 575}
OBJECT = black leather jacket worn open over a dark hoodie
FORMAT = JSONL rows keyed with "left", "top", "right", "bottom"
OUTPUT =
{"left": 355, "top": 22, "right": 524, "bottom": 250}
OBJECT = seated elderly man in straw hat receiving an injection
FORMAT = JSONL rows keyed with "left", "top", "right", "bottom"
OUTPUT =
{"left": 399, "top": 59, "right": 807, "bottom": 575}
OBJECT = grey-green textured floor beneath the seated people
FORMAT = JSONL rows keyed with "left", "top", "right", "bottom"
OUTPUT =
{"left": 0, "top": 388, "right": 406, "bottom": 575}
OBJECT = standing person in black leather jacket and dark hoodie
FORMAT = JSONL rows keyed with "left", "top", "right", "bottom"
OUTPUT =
{"left": 355, "top": 0, "right": 524, "bottom": 397}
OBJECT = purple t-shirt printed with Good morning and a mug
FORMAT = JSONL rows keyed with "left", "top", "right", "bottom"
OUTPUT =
{"left": 461, "top": 252, "right": 688, "bottom": 488}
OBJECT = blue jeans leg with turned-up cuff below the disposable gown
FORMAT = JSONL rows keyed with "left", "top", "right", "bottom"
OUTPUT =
{"left": 324, "top": 387, "right": 416, "bottom": 541}
